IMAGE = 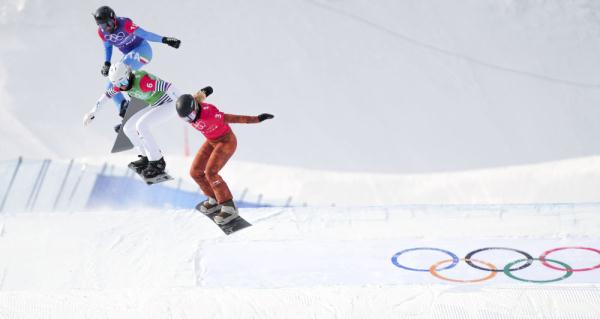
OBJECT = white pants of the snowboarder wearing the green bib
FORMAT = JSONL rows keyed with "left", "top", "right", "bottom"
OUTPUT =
{"left": 123, "top": 85, "right": 179, "bottom": 161}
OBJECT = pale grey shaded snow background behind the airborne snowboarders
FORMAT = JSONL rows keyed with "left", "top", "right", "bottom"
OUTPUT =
{"left": 0, "top": 0, "right": 600, "bottom": 173}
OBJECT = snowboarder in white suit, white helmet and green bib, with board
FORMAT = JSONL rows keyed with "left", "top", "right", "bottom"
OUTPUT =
{"left": 83, "top": 63, "right": 179, "bottom": 179}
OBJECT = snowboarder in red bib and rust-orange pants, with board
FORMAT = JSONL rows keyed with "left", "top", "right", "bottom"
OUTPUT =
{"left": 176, "top": 86, "right": 273, "bottom": 225}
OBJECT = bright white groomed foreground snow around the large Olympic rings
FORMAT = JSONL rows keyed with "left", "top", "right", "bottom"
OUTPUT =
{"left": 0, "top": 204, "right": 600, "bottom": 319}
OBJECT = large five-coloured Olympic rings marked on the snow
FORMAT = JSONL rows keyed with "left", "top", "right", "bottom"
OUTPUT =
{"left": 392, "top": 246, "right": 600, "bottom": 283}
